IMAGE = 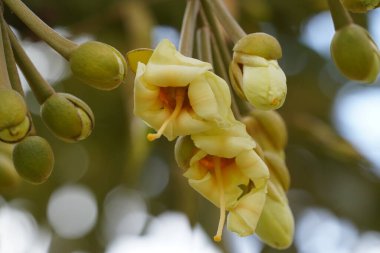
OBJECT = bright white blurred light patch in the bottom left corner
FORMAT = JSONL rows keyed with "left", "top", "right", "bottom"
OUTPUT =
{"left": 0, "top": 205, "right": 51, "bottom": 253}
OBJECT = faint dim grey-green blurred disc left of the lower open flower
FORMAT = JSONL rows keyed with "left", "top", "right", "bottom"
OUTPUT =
{"left": 140, "top": 156, "right": 169, "bottom": 197}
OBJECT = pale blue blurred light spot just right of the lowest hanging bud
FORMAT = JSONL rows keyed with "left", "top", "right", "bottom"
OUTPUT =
{"left": 295, "top": 209, "right": 358, "bottom": 253}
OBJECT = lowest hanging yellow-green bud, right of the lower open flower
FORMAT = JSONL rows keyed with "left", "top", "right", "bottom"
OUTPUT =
{"left": 256, "top": 181, "right": 294, "bottom": 249}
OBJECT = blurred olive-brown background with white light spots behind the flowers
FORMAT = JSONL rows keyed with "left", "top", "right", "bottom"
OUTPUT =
{"left": 0, "top": 0, "right": 380, "bottom": 253}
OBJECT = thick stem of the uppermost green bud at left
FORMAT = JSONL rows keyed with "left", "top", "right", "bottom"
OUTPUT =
{"left": 3, "top": 0, "right": 78, "bottom": 60}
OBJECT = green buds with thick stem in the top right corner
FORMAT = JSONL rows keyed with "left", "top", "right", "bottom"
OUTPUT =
{"left": 329, "top": 0, "right": 380, "bottom": 83}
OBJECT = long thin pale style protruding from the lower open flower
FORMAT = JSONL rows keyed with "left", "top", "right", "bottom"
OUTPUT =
{"left": 214, "top": 157, "right": 226, "bottom": 242}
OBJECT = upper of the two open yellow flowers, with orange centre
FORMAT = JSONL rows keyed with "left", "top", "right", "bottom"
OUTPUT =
{"left": 134, "top": 40, "right": 232, "bottom": 140}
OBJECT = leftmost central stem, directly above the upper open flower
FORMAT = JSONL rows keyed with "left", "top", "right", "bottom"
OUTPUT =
{"left": 179, "top": 0, "right": 199, "bottom": 56}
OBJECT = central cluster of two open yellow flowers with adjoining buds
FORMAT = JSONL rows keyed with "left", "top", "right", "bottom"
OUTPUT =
{"left": 128, "top": 29, "right": 294, "bottom": 248}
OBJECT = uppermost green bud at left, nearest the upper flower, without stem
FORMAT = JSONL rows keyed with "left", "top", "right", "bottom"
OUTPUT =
{"left": 70, "top": 41, "right": 127, "bottom": 90}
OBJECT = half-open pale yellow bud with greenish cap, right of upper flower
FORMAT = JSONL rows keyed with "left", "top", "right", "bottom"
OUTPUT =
{"left": 229, "top": 33, "right": 287, "bottom": 110}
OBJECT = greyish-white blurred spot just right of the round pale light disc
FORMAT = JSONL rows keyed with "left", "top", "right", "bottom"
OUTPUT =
{"left": 103, "top": 186, "right": 148, "bottom": 241}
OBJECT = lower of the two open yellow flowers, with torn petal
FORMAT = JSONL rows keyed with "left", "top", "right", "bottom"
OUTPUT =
{"left": 175, "top": 121, "right": 269, "bottom": 241}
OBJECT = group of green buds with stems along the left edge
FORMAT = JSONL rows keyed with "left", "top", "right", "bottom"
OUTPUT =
{"left": 0, "top": 0, "right": 127, "bottom": 186}
